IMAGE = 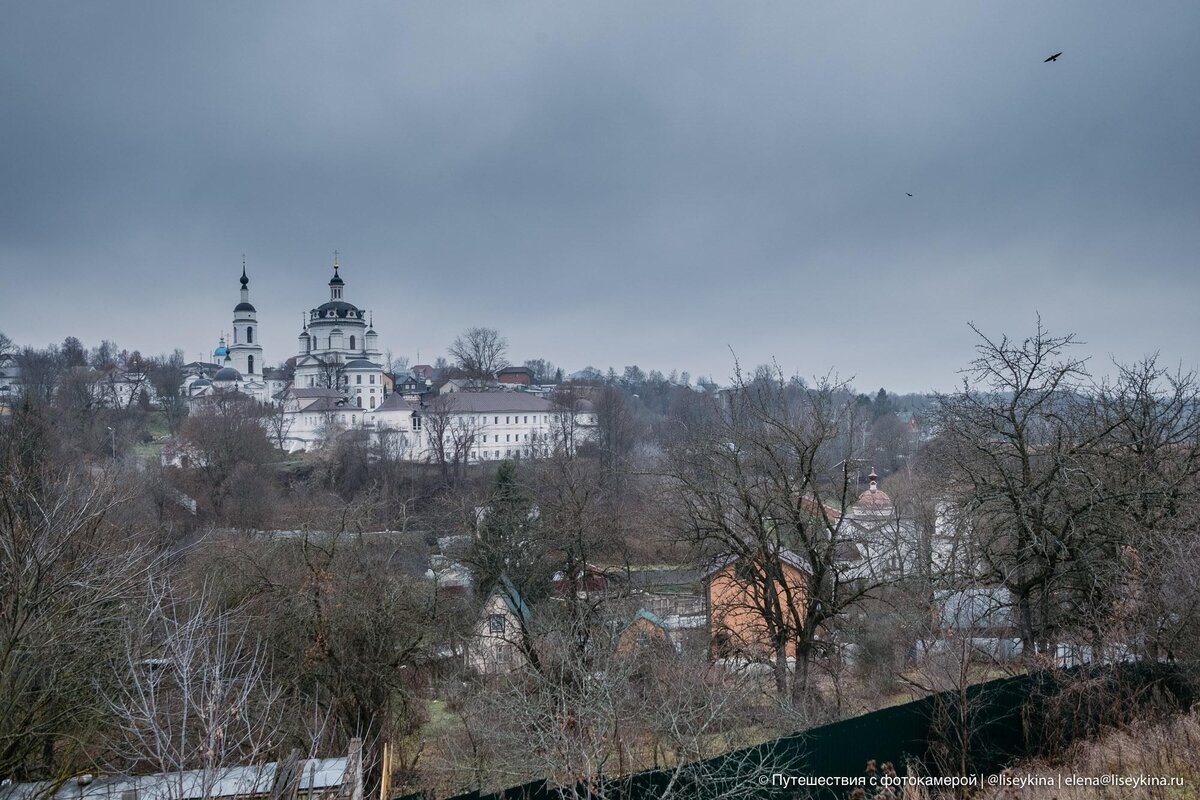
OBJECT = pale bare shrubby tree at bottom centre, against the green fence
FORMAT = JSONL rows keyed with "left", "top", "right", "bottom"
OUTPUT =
{"left": 443, "top": 614, "right": 784, "bottom": 800}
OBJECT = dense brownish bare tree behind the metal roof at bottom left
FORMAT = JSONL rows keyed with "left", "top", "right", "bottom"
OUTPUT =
{"left": 197, "top": 515, "right": 466, "bottom": 792}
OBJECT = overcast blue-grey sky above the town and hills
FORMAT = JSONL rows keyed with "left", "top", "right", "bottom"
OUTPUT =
{"left": 0, "top": 0, "right": 1200, "bottom": 391}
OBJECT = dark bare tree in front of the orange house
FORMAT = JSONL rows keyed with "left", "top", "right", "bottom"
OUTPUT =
{"left": 666, "top": 373, "right": 881, "bottom": 708}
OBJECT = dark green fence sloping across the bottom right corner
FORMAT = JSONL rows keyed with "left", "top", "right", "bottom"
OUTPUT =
{"left": 406, "top": 664, "right": 1192, "bottom": 800}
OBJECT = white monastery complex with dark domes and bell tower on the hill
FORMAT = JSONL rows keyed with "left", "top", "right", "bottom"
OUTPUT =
{"left": 184, "top": 255, "right": 596, "bottom": 462}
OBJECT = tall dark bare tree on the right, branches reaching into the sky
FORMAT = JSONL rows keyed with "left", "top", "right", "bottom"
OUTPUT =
{"left": 936, "top": 320, "right": 1185, "bottom": 663}
